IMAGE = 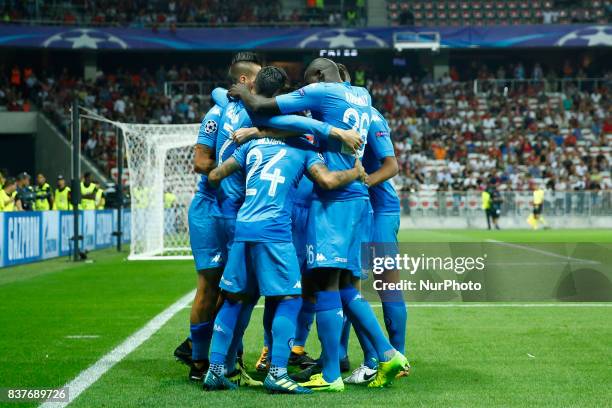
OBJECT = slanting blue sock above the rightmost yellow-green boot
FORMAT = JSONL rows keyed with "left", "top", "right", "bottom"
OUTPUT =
{"left": 340, "top": 285, "right": 394, "bottom": 361}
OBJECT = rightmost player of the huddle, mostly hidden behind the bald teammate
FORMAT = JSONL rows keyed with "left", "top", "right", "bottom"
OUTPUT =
{"left": 338, "top": 64, "right": 409, "bottom": 384}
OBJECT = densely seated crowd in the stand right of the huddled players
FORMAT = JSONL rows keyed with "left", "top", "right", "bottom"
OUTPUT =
{"left": 369, "top": 67, "right": 612, "bottom": 191}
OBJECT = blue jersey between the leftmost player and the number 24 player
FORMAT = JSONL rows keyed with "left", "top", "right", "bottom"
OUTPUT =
{"left": 216, "top": 101, "right": 252, "bottom": 218}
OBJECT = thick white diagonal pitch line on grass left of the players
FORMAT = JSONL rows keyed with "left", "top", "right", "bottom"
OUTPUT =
{"left": 40, "top": 289, "right": 195, "bottom": 408}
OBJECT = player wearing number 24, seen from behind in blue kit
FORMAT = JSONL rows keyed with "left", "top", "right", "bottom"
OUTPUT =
{"left": 204, "top": 67, "right": 365, "bottom": 394}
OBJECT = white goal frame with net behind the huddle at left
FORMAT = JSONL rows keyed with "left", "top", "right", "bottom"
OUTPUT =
{"left": 81, "top": 111, "right": 200, "bottom": 260}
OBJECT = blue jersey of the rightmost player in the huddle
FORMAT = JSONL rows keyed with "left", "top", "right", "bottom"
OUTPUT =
{"left": 363, "top": 108, "right": 400, "bottom": 214}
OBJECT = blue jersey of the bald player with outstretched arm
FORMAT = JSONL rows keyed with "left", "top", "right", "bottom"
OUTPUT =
{"left": 276, "top": 82, "right": 372, "bottom": 201}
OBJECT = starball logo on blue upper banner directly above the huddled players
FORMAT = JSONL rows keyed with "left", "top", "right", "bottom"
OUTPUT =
{"left": 298, "top": 28, "right": 387, "bottom": 48}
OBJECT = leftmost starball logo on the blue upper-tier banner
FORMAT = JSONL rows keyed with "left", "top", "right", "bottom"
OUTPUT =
{"left": 43, "top": 28, "right": 128, "bottom": 50}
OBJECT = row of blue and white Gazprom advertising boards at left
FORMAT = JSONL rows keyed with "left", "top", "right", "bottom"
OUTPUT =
{"left": 0, "top": 210, "right": 130, "bottom": 267}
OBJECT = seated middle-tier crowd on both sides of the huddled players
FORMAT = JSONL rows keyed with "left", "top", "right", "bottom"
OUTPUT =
{"left": 0, "top": 61, "right": 612, "bottom": 191}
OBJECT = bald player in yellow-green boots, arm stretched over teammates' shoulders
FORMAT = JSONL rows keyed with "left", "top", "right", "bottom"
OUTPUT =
{"left": 229, "top": 58, "right": 408, "bottom": 391}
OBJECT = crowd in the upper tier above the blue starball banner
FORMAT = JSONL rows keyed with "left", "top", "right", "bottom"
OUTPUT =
{"left": 0, "top": 0, "right": 365, "bottom": 30}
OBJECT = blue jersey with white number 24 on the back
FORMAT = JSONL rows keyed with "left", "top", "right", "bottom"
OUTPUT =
{"left": 233, "top": 138, "right": 324, "bottom": 242}
